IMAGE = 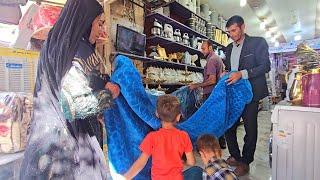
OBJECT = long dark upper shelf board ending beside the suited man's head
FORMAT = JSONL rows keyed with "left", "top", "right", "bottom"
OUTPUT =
{"left": 146, "top": 12, "right": 225, "bottom": 48}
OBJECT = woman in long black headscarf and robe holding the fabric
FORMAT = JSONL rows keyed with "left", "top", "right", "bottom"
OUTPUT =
{"left": 20, "top": 0, "right": 119, "bottom": 179}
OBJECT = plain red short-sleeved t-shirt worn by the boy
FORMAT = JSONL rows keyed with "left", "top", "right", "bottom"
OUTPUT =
{"left": 140, "top": 128, "right": 192, "bottom": 180}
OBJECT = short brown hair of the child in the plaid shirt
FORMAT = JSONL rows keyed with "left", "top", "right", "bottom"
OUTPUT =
{"left": 196, "top": 134, "right": 222, "bottom": 157}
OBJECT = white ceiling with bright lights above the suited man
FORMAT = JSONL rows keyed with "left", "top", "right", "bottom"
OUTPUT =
{"left": 201, "top": 0, "right": 320, "bottom": 44}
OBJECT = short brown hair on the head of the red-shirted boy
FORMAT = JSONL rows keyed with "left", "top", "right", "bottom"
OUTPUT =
{"left": 157, "top": 94, "right": 180, "bottom": 122}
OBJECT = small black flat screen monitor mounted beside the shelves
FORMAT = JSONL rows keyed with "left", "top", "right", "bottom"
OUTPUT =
{"left": 116, "top": 24, "right": 146, "bottom": 56}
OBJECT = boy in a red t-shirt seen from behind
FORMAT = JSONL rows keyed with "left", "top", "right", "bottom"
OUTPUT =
{"left": 124, "top": 95, "right": 195, "bottom": 180}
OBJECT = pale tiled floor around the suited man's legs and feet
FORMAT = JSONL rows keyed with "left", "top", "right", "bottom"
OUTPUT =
{"left": 192, "top": 111, "right": 271, "bottom": 180}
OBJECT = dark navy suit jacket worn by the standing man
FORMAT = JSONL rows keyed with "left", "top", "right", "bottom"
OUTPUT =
{"left": 224, "top": 35, "right": 270, "bottom": 101}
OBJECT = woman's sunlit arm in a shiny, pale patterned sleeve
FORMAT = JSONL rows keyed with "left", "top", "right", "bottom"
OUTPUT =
{"left": 60, "top": 66, "right": 112, "bottom": 121}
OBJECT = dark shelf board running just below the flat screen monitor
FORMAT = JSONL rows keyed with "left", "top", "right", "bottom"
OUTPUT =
{"left": 112, "top": 52, "right": 203, "bottom": 72}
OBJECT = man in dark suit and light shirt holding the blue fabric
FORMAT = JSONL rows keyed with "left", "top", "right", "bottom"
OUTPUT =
{"left": 224, "top": 16, "right": 270, "bottom": 176}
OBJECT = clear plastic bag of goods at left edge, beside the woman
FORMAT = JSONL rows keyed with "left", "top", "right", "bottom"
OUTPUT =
{"left": 0, "top": 92, "right": 32, "bottom": 153}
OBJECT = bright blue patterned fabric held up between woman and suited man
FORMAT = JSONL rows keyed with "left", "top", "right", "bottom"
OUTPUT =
{"left": 104, "top": 56, "right": 252, "bottom": 179}
